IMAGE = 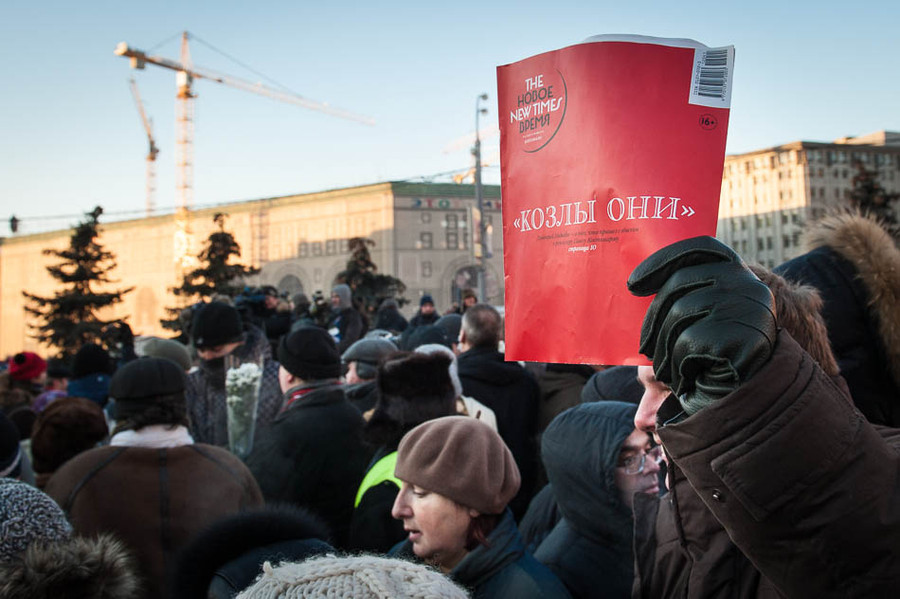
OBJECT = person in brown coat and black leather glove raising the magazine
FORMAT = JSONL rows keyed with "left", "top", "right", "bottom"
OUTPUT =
{"left": 628, "top": 237, "right": 900, "bottom": 597}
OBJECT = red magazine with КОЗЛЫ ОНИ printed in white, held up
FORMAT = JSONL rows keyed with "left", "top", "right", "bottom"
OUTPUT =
{"left": 497, "top": 36, "right": 734, "bottom": 365}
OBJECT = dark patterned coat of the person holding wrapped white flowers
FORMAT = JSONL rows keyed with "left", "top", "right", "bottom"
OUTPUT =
{"left": 184, "top": 326, "right": 282, "bottom": 447}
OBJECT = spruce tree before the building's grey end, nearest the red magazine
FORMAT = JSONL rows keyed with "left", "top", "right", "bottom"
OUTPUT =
{"left": 335, "top": 237, "right": 408, "bottom": 316}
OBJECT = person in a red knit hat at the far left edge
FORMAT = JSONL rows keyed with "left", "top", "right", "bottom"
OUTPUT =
{"left": 0, "top": 352, "right": 47, "bottom": 441}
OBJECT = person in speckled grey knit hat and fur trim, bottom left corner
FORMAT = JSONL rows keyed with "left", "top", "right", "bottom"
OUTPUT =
{"left": 0, "top": 478, "right": 140, "bottom": 599}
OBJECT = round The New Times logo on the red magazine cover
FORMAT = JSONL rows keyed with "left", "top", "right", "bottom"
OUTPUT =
{"left": 509, "top": 70, "right": 568, "bottom": 153}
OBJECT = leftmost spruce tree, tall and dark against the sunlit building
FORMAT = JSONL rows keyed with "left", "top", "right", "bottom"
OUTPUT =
{"left": 22, "top": 206, "right": 134, "bottom": 360}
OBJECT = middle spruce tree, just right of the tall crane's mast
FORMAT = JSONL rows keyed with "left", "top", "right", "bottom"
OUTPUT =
{"left": 161, "top": 212, "right": 259, "bottom": 331}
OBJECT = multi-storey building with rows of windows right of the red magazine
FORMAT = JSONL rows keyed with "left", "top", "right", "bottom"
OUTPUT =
{"left": 717, "top": 131, "right": 900, "bottom": 268}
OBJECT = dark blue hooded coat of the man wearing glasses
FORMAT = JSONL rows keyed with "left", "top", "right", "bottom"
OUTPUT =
{"left": 534, "top": 401, "right": 637, "bottom": 599}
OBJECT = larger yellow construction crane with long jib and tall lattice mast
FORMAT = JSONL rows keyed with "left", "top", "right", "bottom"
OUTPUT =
{"left": 114, "top": 31, "right": 375, "bottom": 268}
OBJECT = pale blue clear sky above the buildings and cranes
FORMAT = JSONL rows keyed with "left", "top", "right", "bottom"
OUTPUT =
{"left": 0, "top": 0, "right": 900, "bottom": 235}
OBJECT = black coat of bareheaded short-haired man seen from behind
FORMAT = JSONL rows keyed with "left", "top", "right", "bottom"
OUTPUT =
{"left": 457, "top": 347, "right": 540, "bottom": 517}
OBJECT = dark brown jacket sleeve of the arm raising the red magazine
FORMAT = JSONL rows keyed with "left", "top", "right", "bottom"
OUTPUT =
{"left": 660, "top": 331, "right": 900, "bottom": 597}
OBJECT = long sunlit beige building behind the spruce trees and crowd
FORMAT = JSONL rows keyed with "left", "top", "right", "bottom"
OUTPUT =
{"left": 0, "top": 182, "right": 503, "bottom": 356}
